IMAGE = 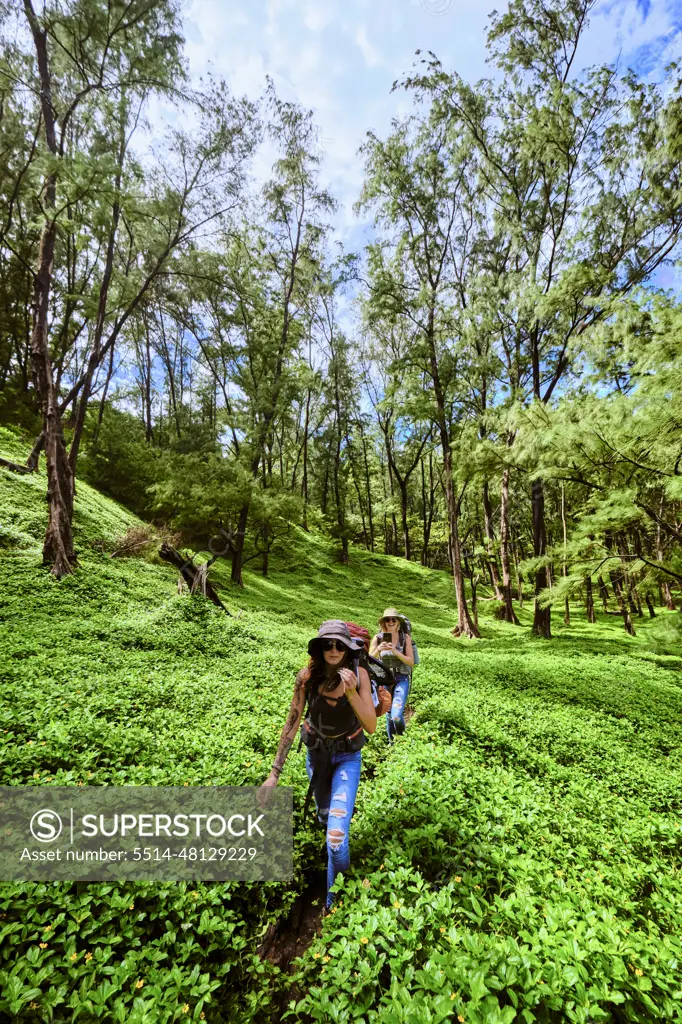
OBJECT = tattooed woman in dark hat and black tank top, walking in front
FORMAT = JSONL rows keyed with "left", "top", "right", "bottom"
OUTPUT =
{"left": 263, "top": 618, "right": 377, "bottom": 909}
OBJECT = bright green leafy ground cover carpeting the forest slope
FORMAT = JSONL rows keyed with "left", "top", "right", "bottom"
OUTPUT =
{"left": 0, "top": 431, "right": 682, "bottom": 1024}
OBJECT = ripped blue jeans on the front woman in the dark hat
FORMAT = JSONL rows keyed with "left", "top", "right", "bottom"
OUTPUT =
{"left": 305, "top": 750, "right": 361, "bottom": 910}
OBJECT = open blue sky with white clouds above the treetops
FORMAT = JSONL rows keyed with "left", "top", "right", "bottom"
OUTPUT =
{"left": 178, "top": 0, "right": 682, "bottom": 272}
